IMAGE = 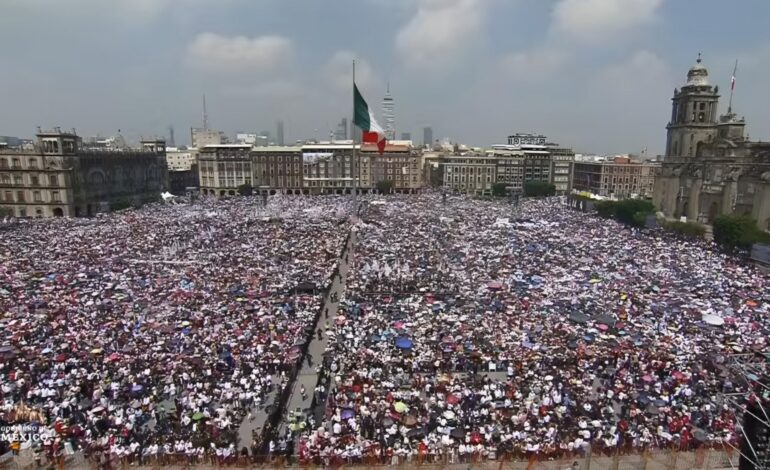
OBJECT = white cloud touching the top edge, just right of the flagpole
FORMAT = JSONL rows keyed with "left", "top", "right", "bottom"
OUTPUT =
{"left": 396, "top": 0, "right": 489, "bottom": 69}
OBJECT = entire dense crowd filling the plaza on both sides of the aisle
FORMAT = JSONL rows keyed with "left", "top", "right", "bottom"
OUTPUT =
{"left": 0, "top": 194, "right": 770, "bottom": 464}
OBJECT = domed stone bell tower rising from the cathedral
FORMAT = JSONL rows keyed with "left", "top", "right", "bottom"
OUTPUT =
{"left": 666, "top": 54, "right": 719, "bottom": 158}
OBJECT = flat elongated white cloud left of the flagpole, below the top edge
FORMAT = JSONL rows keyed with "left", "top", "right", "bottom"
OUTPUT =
{"left": 187, "top": 33, "right": 294, "bottom": 75}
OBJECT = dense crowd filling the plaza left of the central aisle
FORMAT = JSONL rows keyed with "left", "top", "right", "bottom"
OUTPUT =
{"left": 0, "top": 196, "right": 350, "bottom": 461}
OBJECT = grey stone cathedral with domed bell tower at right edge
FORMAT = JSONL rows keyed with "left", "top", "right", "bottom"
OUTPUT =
{"left": 653, "top": 57, "right": 770, "bottom": 230}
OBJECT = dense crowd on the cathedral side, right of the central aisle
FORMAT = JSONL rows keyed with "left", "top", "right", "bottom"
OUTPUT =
{"left": 299, "top": 195, "right": 770, "bottom": 463}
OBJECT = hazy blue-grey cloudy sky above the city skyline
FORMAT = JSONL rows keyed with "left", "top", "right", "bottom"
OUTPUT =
{"left": 0, "top": 0, "right": 770, "bottom": 154}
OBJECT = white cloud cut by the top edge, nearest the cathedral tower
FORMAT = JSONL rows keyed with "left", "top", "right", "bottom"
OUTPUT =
{"left": 553, "top": 0, "right": 663, "bottom": 41}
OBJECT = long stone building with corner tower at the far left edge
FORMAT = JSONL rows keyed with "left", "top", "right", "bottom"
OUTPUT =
{"left": 0, "top": 128, "right": 168, "bottom": 217}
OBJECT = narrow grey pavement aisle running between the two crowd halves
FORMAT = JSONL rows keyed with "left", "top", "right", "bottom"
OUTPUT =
{"left": 280, "top": 230, "right": 356, "bottom": 442}
